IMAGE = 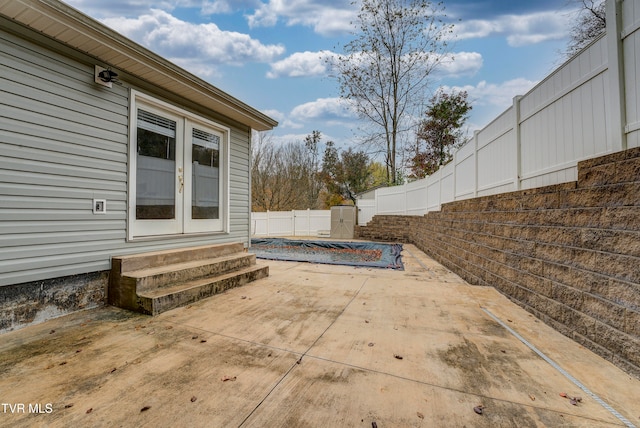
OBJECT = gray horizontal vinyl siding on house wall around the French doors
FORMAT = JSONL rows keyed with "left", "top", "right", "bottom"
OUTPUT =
{"left": 0, "top": 20, "right": 249, "bottom": 286}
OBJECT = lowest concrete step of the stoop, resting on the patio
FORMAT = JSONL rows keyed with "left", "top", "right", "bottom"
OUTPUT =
{"left": 137, "top": 265, "right": 269, "bottom": 315}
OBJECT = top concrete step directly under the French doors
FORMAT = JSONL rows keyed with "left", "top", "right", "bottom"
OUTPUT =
{"left": 112, "top": 242, "right": 244, "bottom": 272}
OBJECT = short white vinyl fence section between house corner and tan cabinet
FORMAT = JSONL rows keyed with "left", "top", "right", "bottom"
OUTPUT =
{"left": 251, "top": 210, "right": 331, "bottom": 237}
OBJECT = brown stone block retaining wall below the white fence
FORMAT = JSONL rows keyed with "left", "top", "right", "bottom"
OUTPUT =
{"left": 356, "top": 148, "right": 640, "bottom": 378}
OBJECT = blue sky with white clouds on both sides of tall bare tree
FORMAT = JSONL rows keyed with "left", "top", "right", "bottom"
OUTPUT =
{"left": 66, "top": 0, "right": 575, "bottom": 153}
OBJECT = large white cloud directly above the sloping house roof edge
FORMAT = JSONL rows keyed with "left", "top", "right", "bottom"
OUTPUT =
{"left": 103, "top": 9, "right": 285, "bottom": 76}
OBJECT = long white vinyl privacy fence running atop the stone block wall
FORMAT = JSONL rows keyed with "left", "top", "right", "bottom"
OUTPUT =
{"left": 358, "top": 0, "right": 640, "bottom": 224}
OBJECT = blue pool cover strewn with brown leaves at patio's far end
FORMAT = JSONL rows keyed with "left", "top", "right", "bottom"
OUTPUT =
{"left": 249, "top": 238, "right": 404, "bottom": 270}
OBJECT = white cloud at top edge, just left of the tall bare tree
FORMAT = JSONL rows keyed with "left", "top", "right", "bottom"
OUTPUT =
{"left": 247, "top": 0, "right": 357, "bottom": 36}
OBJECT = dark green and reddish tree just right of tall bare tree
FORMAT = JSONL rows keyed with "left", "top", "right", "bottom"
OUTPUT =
{"left": 409, "top": 91, "right": 472, "bottom": 178}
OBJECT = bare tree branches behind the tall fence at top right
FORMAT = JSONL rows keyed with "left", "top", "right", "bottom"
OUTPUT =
{"left": 565, "top": 0, "right": 607, "bottom": 57}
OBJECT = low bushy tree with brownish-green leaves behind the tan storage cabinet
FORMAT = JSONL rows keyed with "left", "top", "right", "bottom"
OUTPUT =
{"left": 322, "top": 141, "right": 372, "bottom": 206}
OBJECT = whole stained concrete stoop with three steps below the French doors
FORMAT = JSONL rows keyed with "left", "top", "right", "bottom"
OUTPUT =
{"left": 108, "top": 243, "right": 269, "bottom": 315}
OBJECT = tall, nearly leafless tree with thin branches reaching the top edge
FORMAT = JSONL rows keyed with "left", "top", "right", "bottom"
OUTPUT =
{"left": 333, "top": 0, "right": 453, "bottom": 184}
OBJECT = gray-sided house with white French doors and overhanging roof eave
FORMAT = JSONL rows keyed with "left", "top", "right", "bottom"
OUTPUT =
{"left": 0, "top": 0, "right": 277, "bottom": 332}
